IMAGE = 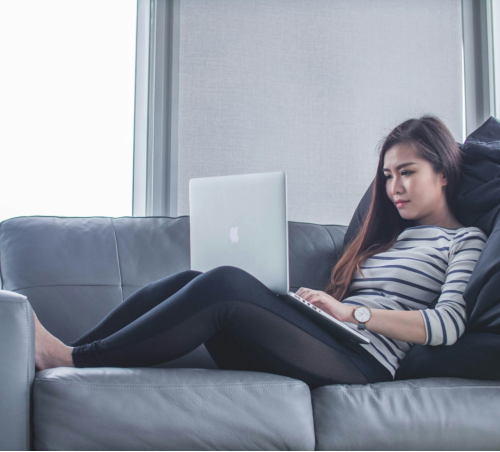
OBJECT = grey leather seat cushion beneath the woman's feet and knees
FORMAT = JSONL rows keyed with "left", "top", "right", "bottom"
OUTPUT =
{"left": 33, "top": 368, "right": 315, "bottom": 450}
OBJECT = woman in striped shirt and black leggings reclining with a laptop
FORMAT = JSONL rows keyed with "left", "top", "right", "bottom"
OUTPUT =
{"left": 35, "top": 116, "right": 487, "bottom": 389}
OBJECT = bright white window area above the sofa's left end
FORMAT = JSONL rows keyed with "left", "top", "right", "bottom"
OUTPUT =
{"left": 0, "top": 0, "right": 137, "bottom": 221}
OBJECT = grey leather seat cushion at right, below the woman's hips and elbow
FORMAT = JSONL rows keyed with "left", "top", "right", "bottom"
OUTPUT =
{"left": 312, "top": 378, "right": 500, "bottom": 450}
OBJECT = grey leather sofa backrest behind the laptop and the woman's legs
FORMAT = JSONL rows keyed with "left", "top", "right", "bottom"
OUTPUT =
{"left": 0, "top": 216, "right": 347, "bottom": 344}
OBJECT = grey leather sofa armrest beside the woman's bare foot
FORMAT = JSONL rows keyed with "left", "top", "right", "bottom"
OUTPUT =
{"left": 0, "top": 290, "right": 35, "bottom": 450}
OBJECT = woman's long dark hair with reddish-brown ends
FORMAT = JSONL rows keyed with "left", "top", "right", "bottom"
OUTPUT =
{"left": 325, "top": 115, "right": 464, "bottom": 301}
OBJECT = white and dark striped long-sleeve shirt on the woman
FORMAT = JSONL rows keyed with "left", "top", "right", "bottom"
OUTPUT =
{"left": 343, "top": 226, "right": 487, "bottom": 378}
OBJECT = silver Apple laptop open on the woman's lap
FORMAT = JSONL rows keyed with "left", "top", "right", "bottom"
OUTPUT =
{"left": 189, "top": 171, "right": 371, "bottom": 344}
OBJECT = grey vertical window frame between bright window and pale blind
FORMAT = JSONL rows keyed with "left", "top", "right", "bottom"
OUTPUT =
{"left": 132, "top": 0, "right": 180, "bottom": 217}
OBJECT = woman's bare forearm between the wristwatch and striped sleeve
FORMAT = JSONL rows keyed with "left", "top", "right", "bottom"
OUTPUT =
{"left": 343, "top": 305, "right": 427, "bottom": 344}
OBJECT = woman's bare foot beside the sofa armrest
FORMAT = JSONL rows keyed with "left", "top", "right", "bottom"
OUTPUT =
{"left": 33, "top": 312, "right": 75, "bottom": 372}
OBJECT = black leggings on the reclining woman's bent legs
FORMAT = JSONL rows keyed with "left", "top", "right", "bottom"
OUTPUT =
{"left": 70, "top": 266, "right": 393, "bottom": 389}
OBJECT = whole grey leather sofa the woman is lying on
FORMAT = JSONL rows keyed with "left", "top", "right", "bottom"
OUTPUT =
{"left": 0, "top": 216, "right": 500, "bottom": 450}
